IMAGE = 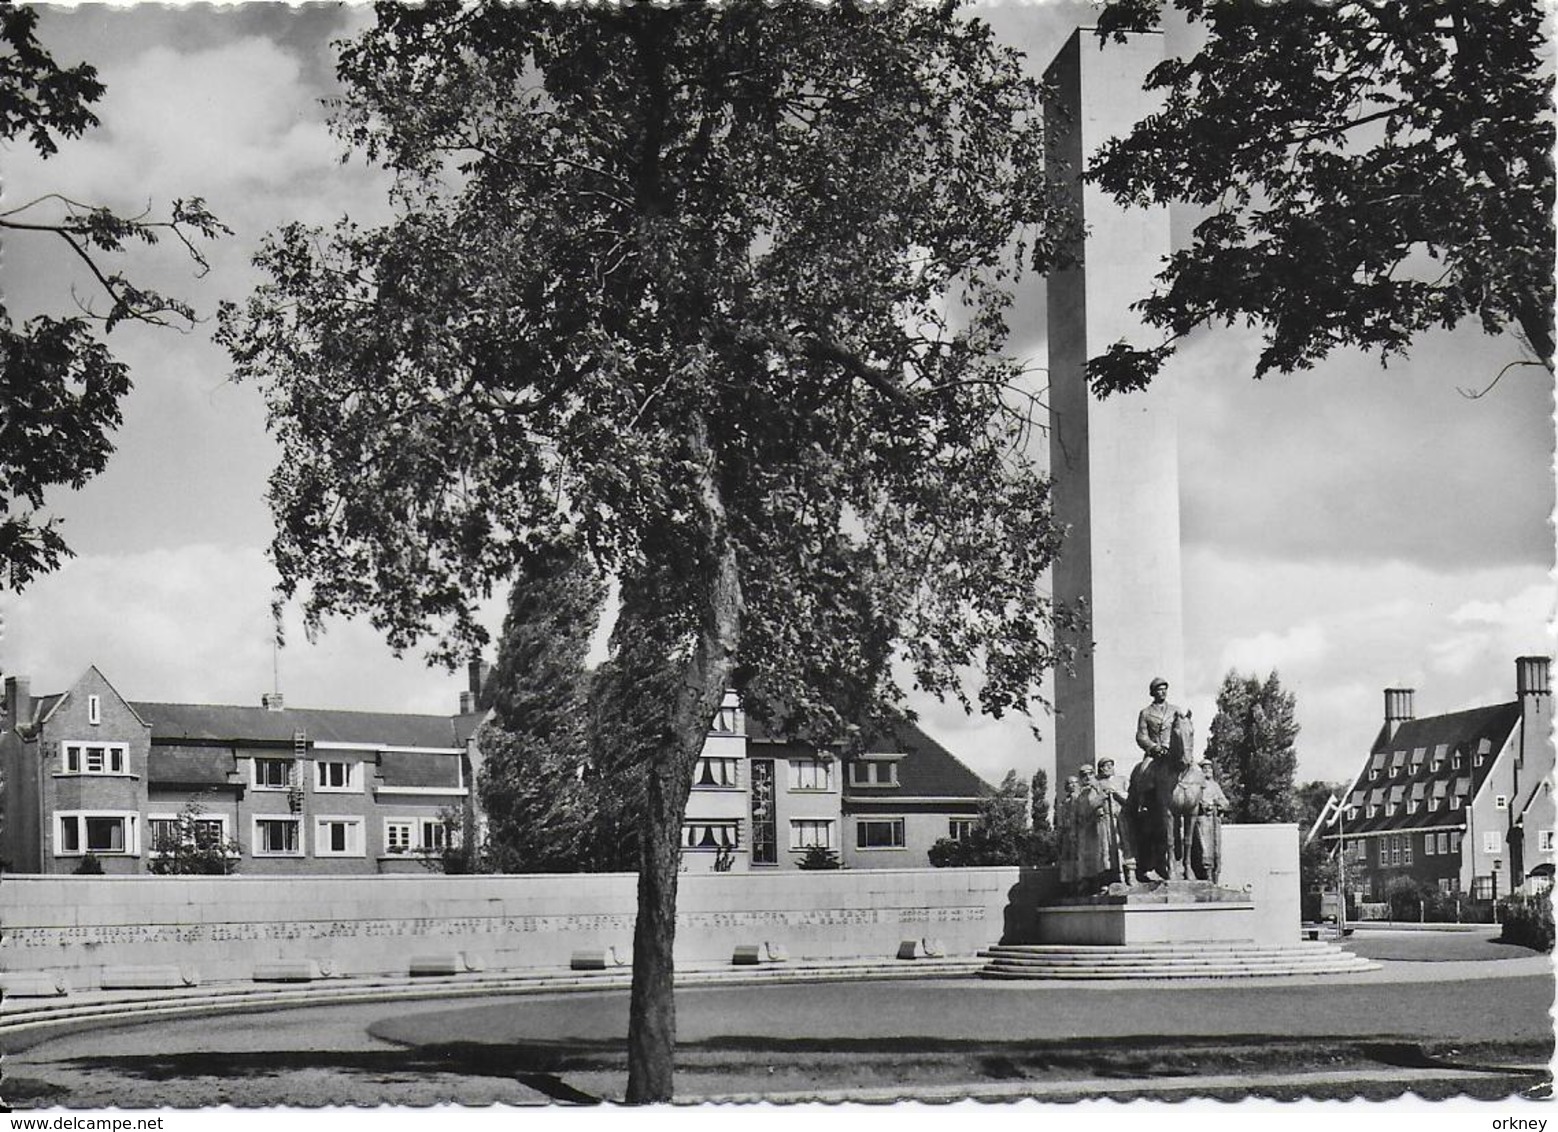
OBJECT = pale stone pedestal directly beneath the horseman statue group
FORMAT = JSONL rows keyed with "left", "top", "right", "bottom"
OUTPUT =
{"left": 1038, "top": 880, "right": 1259, "bottom": 947}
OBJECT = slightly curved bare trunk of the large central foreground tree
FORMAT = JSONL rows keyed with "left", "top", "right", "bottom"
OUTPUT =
{"left": 626, "top": 416, "right": 742, "bottom": 1104}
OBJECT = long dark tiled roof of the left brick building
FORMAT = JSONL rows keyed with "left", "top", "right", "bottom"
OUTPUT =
{"left": 131, "top": 704, "right": 467, "bottom": 747}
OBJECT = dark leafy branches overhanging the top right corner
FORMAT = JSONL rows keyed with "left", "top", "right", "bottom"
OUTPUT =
{"left": 1087, "top": 0, "right": 1553, "bottom": 392}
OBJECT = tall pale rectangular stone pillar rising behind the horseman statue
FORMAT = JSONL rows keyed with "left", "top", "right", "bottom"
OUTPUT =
{"left": 1047, "top": 28, "right": 1184, "bottom": 794}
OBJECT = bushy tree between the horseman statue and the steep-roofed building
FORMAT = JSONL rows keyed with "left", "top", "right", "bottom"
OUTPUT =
{"left": 1206, "top": 671, "right": 1313, "bottom": 824}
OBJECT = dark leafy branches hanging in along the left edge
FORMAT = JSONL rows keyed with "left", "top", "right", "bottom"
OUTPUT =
{"left": 0, "top": 3, "right": 227, "bottom": 590}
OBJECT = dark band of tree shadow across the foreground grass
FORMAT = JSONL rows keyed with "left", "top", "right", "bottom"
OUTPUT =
{"left": 54, "top": 1034, "right": 1552, "bottom": 1104}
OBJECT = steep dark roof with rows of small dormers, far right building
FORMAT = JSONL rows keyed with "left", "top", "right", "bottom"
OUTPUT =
{"left": 1329, "top": 702, "right": 1521, "bottom": 835}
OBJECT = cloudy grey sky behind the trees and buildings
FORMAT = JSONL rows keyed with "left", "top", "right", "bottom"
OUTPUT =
{"left": 0, "top": 3, "right": 1553, "bottom": 797}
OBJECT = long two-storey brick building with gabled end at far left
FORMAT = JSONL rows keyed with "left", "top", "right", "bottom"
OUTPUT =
{"left": 0, "top": 668, "right": 483, "bottom": 874}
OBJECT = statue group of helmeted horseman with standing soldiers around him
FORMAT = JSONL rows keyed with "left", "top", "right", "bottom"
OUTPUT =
{"left": 1055, "top": 677, "right": 1228, "bottom": 895}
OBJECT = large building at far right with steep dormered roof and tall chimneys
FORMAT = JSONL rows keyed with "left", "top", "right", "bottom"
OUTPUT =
{"left": 1321, "top": 657, "right": 1555, "bottom": 900}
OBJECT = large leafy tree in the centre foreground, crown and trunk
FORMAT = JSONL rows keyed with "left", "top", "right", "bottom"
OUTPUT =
{"left": 221, "top": 3, "right": 1078, "bottom": 1101}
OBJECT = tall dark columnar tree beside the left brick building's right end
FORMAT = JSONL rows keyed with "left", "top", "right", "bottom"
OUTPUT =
{"left": 477, "top": 545, "right": 606, "bottom": 872}
